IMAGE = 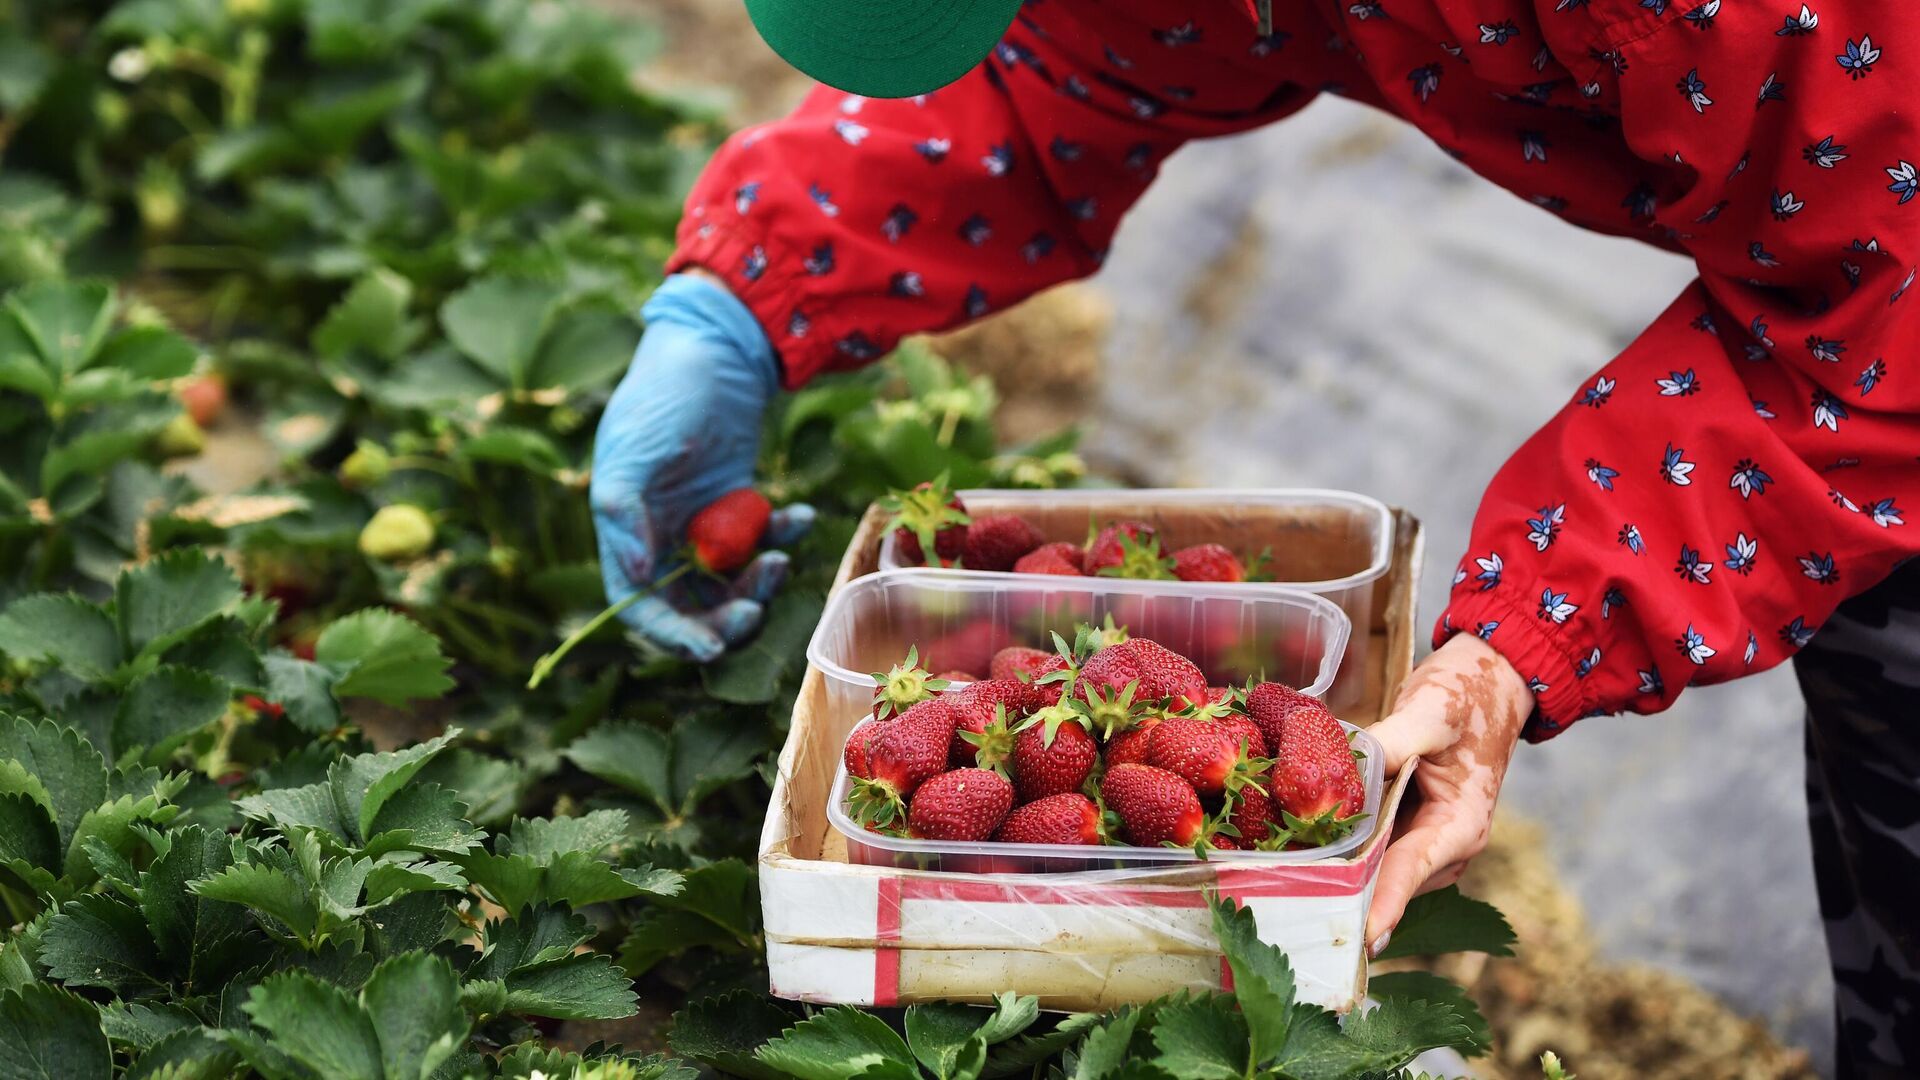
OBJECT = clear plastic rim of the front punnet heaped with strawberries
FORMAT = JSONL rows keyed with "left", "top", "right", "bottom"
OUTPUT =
{"left": 828, "top": 721, "right": 1386, "bottom": 874}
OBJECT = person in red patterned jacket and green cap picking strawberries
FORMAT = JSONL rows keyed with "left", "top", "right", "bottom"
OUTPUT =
{"left": 593, "top": 0, "right": 1920, "bottom": 1076}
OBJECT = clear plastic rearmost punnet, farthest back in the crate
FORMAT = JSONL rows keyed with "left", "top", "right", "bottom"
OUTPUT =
{"left": 879, "top": 488, "right": 1394, "bottom": 709}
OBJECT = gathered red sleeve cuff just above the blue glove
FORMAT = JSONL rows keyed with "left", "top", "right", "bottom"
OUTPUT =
{"left": 666, "top": 215, "right": 833, "bottom": 390}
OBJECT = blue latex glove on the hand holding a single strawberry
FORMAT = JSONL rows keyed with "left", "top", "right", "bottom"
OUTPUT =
{"left": 591, "top": 275, "right": 814, "bottom": 663}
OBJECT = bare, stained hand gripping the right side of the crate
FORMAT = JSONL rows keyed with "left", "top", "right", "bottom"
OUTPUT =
{"left": 1367, "top": 634, "right": 1534, "bottom": 955}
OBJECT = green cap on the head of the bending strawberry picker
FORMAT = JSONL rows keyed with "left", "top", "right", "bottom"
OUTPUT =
{"left": 747, "top": 0, "right": 1021, "bottom": 98}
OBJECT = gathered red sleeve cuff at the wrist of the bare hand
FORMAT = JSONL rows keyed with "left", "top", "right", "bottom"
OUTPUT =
{"left": 1434, "top": 592, "right": 1599, "bottom": 742}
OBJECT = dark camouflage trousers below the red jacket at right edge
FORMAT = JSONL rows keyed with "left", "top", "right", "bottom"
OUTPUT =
{"left": 1793, "top": 559, "right": 1920, "bottom": 1080}
